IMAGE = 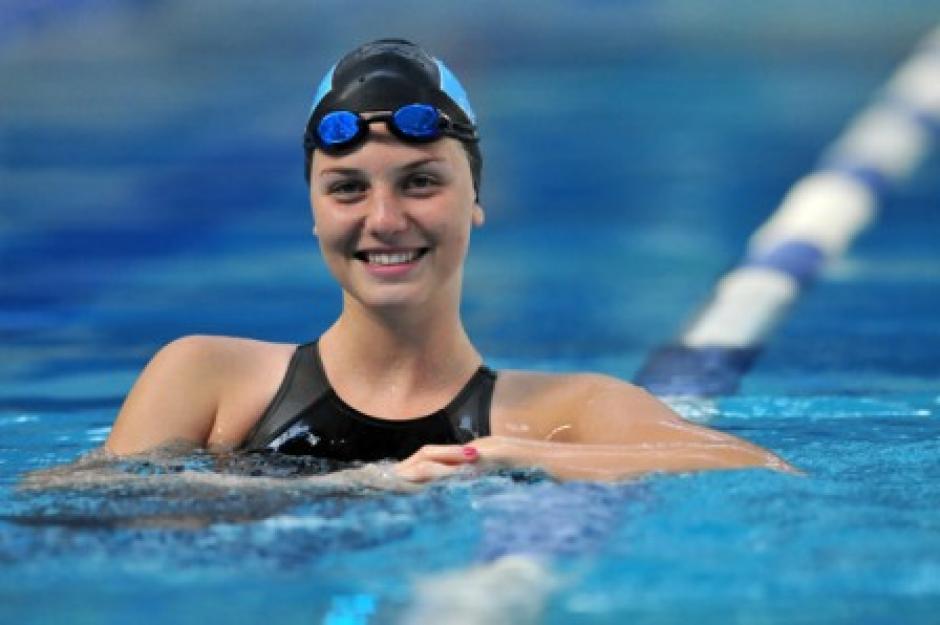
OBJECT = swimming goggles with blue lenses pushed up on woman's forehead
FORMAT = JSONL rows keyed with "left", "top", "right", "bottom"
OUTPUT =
{"left": 304, "top": 103, "right": 479, "bottom": 153}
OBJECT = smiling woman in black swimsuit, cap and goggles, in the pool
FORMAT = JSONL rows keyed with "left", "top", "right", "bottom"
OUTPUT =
{"left": 105, "top": 40, "right": 788, "bottom": 481}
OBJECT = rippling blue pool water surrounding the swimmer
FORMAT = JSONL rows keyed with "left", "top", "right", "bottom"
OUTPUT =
{"left": 0, "top": 0, "right": 940, "bottom": 625}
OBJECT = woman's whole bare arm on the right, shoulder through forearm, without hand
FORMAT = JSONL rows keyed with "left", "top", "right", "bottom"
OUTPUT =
{"left": 471, "top": 373, "right": 795, "bottom": 481}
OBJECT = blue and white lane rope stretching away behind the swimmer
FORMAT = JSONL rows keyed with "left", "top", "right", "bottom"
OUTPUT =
{"left": 635, "top": 26, "right": 940, "bottom": 397}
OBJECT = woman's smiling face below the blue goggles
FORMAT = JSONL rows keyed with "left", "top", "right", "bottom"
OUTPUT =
{"left": 310, "top": 124, "right": 483, "bottom": 309}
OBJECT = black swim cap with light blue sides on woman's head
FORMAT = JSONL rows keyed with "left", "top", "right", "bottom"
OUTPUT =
{"left": 304, "top": 39, "right": 483, "bottom": 195}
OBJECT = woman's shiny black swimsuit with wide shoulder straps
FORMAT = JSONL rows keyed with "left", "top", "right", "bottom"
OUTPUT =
{"left": 241, "top": 342, "right": 496, "bottom": 461}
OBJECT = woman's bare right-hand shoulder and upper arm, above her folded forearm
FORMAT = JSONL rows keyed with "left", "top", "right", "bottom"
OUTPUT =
{"left": 492, "top": 371, "right": 679, "bottom": 442}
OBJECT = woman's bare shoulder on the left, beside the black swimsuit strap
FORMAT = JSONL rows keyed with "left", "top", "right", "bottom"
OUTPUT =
{"left": 106, "top": 335, "right": 296, "bottom": 453}
